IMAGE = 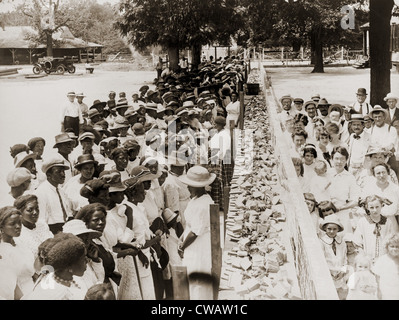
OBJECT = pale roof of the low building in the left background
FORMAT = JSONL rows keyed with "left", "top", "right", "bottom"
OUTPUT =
{"left": 0, "top": 26, "right": 103, "bottom": 49}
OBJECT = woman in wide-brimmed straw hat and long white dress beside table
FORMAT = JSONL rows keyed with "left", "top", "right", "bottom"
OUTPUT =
{"left": 178, "top": 166, "right": 216, "bottom": 300}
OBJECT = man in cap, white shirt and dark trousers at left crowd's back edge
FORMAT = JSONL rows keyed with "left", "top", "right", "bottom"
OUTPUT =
{"left": 60, "top": 91, "right": 84, "bottom": 135}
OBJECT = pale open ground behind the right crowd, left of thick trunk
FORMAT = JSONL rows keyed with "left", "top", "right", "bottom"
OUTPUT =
{"left": 266, "top": 66, "right": 399, "bottom": 105}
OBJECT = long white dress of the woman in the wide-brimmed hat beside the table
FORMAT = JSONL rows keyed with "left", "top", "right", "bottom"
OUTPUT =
{"left": 182, "top": 194, "right": 214, "bottom": 300}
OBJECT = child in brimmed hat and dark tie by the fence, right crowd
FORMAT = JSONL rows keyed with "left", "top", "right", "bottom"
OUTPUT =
{"left": 319, "top": 214, "right": 349, "bottom": 300}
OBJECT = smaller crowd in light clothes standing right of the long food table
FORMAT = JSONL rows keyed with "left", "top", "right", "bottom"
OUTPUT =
{"left": 279, "top": 88, "right": 399, "bottom": 300}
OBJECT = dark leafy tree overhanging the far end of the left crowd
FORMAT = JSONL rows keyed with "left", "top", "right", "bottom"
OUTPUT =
{"left": 116, "top": 0, "right": 242, "bottom": 70}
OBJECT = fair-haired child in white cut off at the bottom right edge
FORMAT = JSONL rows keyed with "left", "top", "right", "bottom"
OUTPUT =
{"left": 371, "top": 233, "right": 399, "bottom": 300}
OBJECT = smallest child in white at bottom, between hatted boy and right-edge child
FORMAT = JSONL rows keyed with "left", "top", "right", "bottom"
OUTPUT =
{"left": 346, "top": 254, "right": 377, "bottom": 300}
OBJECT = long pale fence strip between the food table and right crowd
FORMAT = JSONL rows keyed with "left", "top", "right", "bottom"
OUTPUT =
{"left": 259, "top": 63, "right": 338, "bottom": 300}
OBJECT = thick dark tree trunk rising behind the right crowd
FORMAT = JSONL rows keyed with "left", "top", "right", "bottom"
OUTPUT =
{"left": 369, "top": 0, "right": 394, "bottom": 108}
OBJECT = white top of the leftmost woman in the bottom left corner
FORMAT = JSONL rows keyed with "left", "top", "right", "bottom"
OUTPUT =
{"left": 0, "top": 242, "right": 35, "bottom": 295}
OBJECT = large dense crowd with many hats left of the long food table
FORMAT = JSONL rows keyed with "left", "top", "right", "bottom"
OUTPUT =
{"left": 0, "top": 56, "right": 250, "bottom": 300}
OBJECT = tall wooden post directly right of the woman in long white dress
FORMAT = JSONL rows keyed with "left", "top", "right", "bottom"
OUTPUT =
{"left": 209, "top": 204, "right": 222, "bottom": 300}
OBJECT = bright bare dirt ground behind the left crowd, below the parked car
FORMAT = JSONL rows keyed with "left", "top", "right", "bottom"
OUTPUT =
{"left": 0, "top": 65, "right": 156, "bottom": 197}
